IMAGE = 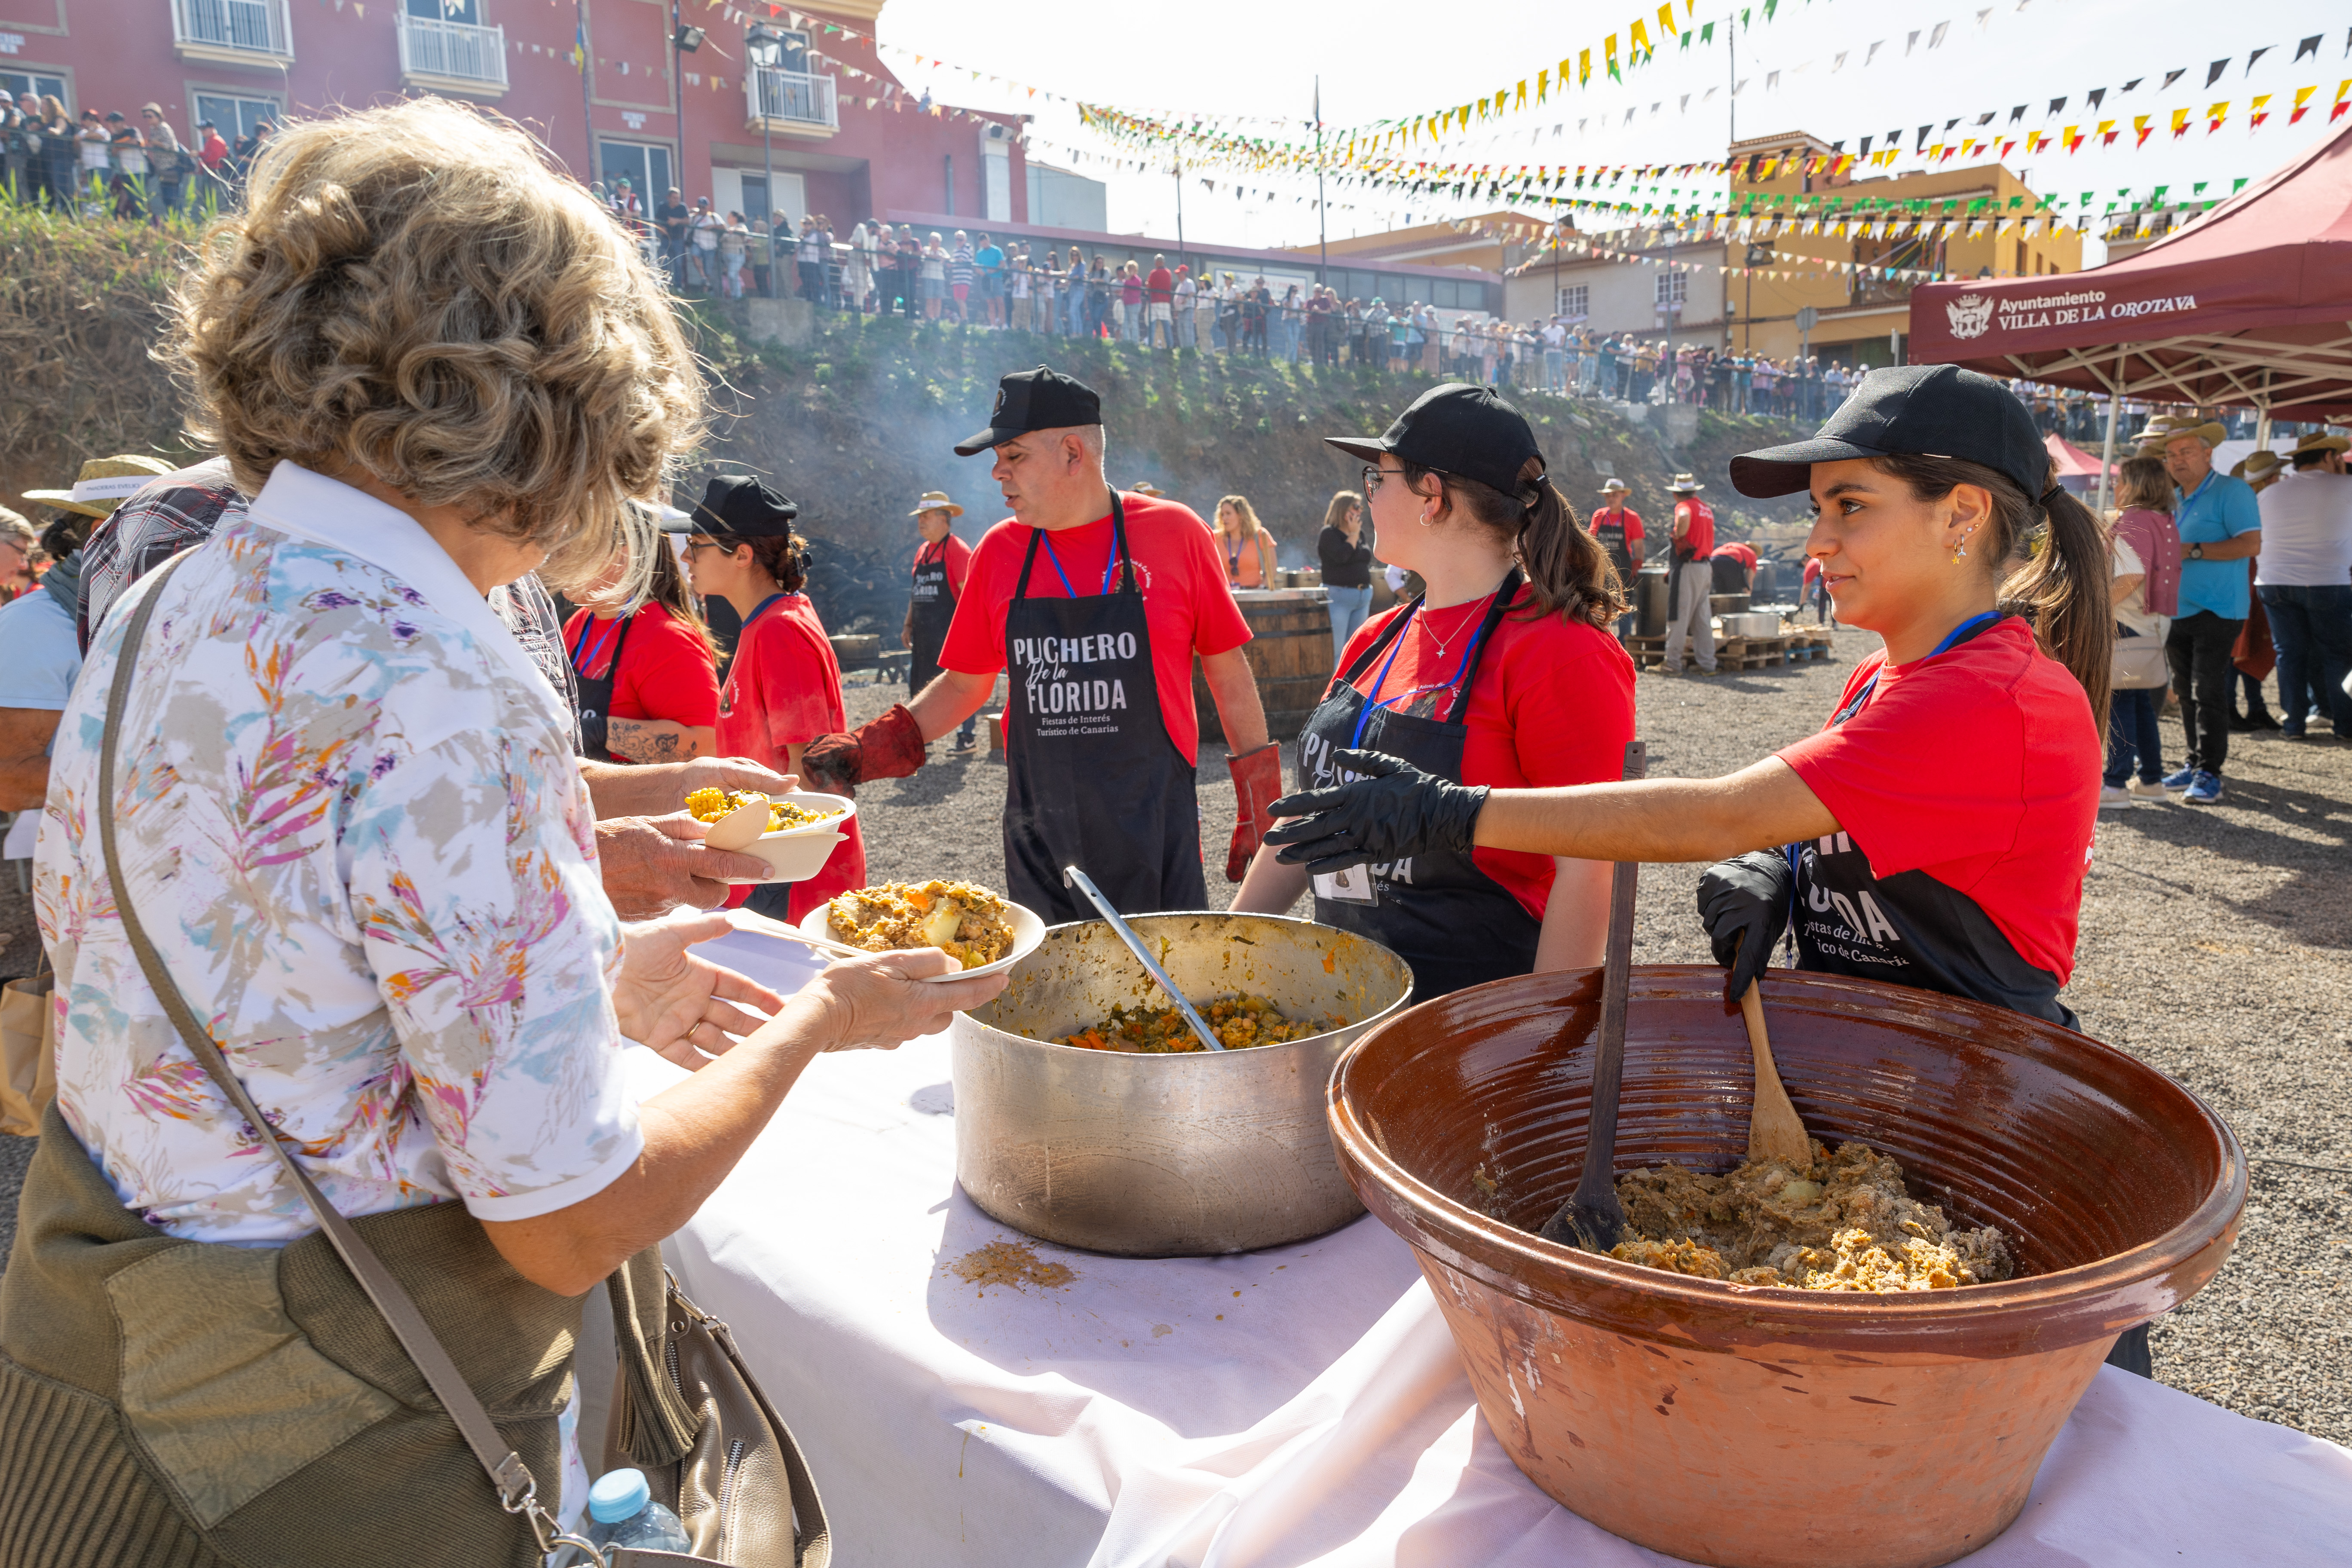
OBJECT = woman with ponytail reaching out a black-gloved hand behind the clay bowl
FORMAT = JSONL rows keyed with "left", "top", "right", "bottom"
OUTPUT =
{"left": 1265, "top": 364, "right": 2114, "bottom": 1027}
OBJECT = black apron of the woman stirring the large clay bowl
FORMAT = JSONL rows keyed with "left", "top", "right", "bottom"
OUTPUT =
{"left": 1783, "top": 611, "right": 2074, "bottom": 1030}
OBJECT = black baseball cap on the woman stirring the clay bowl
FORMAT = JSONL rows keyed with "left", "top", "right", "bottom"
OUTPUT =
{"left": 1731, "top": 364, "right": 2051, "bottom": 496}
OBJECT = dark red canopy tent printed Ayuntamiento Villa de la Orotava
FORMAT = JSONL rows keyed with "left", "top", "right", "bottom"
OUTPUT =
{"left": 1910, "top": 127, "right": 2352, "bottom": 487}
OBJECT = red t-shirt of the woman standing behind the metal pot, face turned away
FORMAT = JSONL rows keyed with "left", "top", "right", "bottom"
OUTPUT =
{"left": 1338, "top": 590, "right": 1632, "bottom": 919}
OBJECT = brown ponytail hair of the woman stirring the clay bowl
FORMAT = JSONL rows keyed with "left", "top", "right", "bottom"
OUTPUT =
{"left": 1872, "top": 456, "right": 2114, "bottom": 719}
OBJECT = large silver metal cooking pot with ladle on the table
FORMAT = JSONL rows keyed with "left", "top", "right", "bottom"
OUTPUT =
{"left": 950, "top": 915, "right": 1414, "bottom": 1258}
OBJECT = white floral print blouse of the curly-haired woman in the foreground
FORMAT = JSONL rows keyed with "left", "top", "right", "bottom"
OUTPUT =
{"left": 33, "top": 463, "right": 642, "bottom": 1246}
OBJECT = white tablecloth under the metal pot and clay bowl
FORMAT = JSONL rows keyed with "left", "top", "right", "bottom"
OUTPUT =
{"left": 630, "top": 938, "right": 2352, "bottom": 1568}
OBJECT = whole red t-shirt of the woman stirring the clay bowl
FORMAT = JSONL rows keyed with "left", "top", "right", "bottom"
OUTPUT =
{"left": 1778, "top": 616, "right": 2103, "bottom": 985}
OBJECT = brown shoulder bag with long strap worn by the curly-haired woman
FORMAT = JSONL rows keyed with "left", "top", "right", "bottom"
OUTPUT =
{"left": 99, "top": 555, "right": 833, "bottom": 1568}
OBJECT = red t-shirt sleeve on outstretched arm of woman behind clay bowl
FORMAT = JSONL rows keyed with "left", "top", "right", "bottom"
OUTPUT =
{"left": 1778, "top": 663, "right": 2025, "bottom": 893}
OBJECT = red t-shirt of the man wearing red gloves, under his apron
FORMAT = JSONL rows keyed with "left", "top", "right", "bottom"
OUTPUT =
{"left": 938, "top": 491, "right": 1249, "bottom": 762}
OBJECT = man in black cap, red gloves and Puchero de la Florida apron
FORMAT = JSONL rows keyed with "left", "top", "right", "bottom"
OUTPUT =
{"left": 802, "top": 364, "right": 1282, "bottom": 922}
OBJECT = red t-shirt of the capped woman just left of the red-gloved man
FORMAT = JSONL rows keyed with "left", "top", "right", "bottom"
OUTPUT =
{"left": 720, "top": 592, "right": 866, "bottom": 919}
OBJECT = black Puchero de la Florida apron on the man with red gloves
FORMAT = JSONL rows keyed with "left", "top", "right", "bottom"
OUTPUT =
{"left": 1004, "top": 491, "right": 1209, "bottom": 926}
